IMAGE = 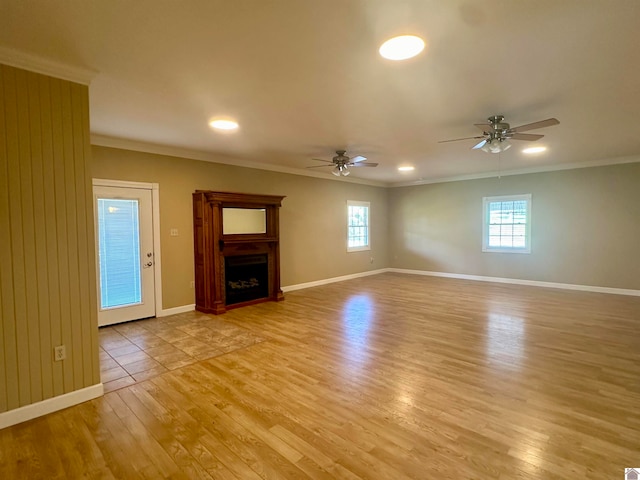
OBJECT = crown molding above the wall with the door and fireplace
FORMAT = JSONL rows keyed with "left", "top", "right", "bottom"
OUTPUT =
{"left": 91, "top": 133, "right": 388, "bottom": 187}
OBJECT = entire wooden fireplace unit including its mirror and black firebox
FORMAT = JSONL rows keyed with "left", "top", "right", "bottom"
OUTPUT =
{"left": 193, "top": 190, "right": 284, "bottom": 315}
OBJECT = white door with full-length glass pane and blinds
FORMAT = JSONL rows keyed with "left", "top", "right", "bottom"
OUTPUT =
{"left": 93, "top": 185, "right": 156, "bottom": 326}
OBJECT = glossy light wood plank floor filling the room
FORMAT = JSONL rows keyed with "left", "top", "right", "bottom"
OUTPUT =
{"left": 0, "top": 273, "right": 640, "bottom": 480}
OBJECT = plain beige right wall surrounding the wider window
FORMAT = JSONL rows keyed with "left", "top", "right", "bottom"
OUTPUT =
{"left": 389, "top": 163, "right": 640, "bottom": 289}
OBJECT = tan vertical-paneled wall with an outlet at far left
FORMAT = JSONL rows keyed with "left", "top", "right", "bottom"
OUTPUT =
{"left": 0, "top": 65, "right": 100, "bottom": 412}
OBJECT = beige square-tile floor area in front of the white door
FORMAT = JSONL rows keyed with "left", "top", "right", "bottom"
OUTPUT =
{"left": 99, "top": 312, "right": 265, "bottom": 392}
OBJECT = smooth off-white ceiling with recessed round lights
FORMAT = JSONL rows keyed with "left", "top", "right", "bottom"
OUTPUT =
{"left": 0, "top": 0, "right": 640, "bottom": 185}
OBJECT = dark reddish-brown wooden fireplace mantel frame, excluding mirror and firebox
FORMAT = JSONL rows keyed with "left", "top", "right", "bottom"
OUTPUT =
{"left": 193, "top": 190, "right": 285, "bottom": 315}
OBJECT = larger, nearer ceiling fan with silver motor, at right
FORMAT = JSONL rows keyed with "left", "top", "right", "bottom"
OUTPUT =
{"left": 438, "top": 115, "right": 560, "bottom": 153}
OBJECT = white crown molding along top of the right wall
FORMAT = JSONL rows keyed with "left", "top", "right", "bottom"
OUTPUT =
{"left": 388, "top": 155, "right": 640, "bottom": 188}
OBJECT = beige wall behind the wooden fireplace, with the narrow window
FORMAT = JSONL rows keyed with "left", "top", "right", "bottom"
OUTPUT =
{"left": 92, "top": 146, "right": 388, "bottom": 309}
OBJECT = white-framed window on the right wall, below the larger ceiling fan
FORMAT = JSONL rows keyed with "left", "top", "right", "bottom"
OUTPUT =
{"left": 482, "top": 194, "right": 531, "bottom": 253}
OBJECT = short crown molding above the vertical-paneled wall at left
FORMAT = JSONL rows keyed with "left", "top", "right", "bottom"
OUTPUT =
{"left": 0, "top": 46, "right": 98, "bottom": 85}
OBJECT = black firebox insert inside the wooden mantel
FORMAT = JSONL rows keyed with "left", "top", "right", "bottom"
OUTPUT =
{"left": 224, "top": 255, "right": 269, "bottom": 305}
